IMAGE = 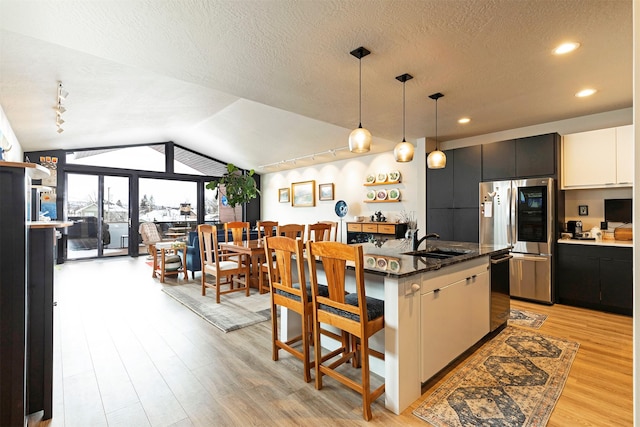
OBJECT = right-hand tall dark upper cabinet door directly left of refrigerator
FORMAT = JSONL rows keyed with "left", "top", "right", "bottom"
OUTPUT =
{"left": 452, "top": 145, "right": 482, "bottom": 209}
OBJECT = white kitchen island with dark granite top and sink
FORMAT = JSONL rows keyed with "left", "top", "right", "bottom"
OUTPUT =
{"left": 282, "top": 239, "right": 508, "bottom": 414}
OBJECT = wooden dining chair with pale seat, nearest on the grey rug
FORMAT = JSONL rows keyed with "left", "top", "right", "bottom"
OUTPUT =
{"left": 198, "top": 224, "right": 250, "bottom": 303}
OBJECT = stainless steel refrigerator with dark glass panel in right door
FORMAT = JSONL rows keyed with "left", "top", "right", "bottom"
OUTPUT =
{"left": 480, "top": 178, "right": 555, "bottom": 304}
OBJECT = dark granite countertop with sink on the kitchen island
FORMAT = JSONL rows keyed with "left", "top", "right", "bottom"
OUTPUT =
{"left": 362, "top": 239, "right": 509, "bottom": 278}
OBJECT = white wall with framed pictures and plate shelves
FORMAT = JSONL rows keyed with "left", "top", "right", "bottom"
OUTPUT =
{"left": 261, "top": 146, "right": 425, "bottom": 242}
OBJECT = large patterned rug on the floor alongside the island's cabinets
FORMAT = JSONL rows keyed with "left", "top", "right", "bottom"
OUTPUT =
{"left": 413, "top": 326, "right": 579, "bottom": 427}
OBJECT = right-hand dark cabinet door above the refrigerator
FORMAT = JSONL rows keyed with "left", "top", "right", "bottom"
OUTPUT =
{"left": 516, "top": 133, "right": 560, "bottom": 178}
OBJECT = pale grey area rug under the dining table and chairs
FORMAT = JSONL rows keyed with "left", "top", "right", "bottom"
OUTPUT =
{"left": 162, "top": 282, "right": 271, "bottom": 332}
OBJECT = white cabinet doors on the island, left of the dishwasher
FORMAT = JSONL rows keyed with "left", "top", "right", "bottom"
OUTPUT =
{"left": 420, "top": 257, "right": 490, "bottom": 382}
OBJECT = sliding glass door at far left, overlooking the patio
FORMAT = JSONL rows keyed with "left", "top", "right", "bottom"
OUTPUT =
{"left": 66, "top": 173, "right": 129, "bottom": 260}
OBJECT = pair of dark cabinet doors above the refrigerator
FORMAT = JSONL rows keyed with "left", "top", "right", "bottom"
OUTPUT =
{"left": 482, "top": 133, "right": 560, "bottom": 181}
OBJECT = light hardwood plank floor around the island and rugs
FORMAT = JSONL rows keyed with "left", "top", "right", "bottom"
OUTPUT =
{"left": 29, "top": 257, "right": 633, "bottom": 427}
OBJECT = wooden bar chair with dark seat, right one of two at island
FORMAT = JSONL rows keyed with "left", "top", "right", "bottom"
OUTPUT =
{"left": 307, "top": 241, "right": 385, "bottom": 421}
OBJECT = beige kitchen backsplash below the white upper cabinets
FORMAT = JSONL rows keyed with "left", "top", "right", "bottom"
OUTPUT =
{"left": 564, "top": 187, "right": 633, "bottom": 230}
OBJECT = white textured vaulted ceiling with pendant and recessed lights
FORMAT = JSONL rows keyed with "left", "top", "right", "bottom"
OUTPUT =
{"left": 0, "top": 0, "right": 633, "bottom": 171}
